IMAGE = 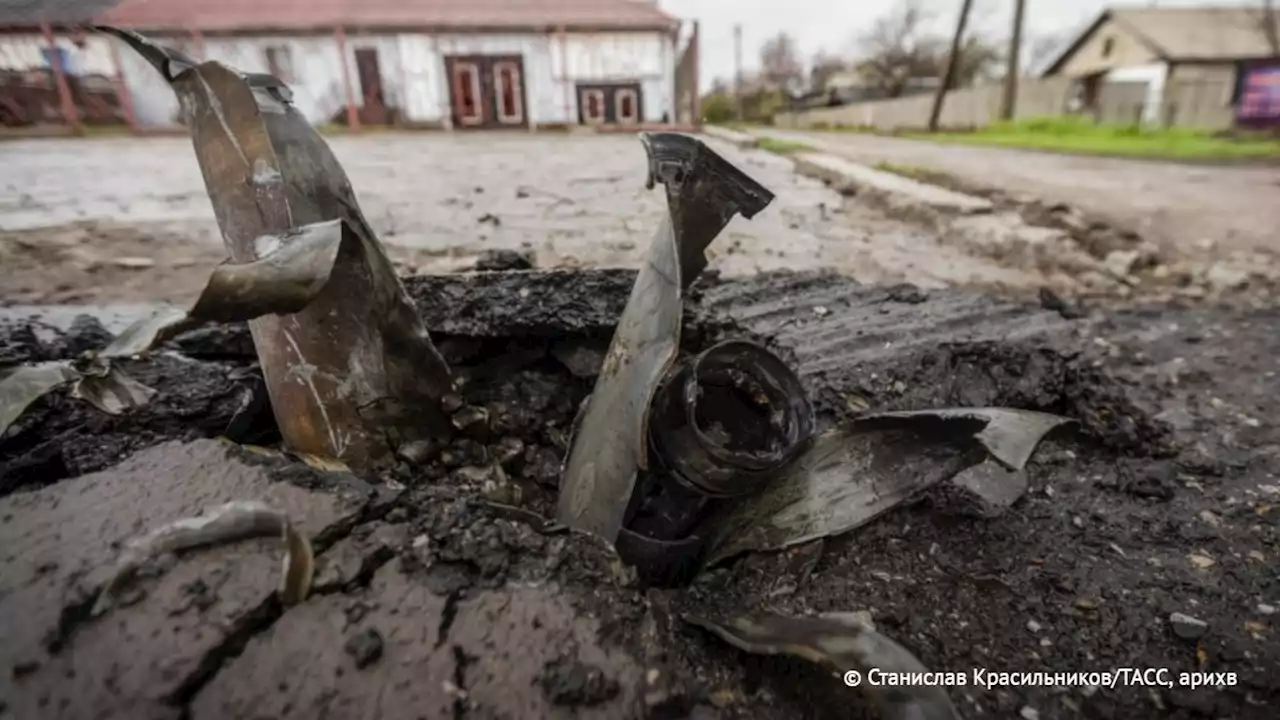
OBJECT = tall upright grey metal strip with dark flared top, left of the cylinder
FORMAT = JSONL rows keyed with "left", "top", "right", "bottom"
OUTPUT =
{"left": 558, "top": 133, "right": 773, "bottom": 542}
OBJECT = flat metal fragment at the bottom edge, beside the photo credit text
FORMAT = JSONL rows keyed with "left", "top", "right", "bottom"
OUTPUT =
{"left": 686, "top": 614, "right": 960, "bottom": 720}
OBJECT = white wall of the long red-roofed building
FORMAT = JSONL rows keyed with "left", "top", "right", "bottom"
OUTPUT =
{"left": 58, "top": 32, "right": 676, "bottom": 127}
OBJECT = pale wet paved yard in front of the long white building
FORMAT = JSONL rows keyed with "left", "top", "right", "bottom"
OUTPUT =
{"left": 0, "top": 133, "right": 1039, "bottom": 302}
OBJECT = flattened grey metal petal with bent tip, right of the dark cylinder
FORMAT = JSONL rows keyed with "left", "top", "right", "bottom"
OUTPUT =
{"left": 707, "top": 407, "right": 1071, "bottom": 564}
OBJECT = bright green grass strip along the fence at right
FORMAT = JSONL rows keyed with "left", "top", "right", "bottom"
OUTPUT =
{"left": 906, "top": 118, "right": 1280, "bottom": 159}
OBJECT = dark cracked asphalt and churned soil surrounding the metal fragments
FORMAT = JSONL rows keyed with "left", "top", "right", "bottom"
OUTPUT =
{"left": 0, "top": 272, "right": 1280, "bottom": 719}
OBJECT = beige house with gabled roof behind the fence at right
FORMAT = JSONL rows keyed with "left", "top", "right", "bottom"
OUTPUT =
{"left": 1043, "top": 4, "right": 1280, "bottom": 124}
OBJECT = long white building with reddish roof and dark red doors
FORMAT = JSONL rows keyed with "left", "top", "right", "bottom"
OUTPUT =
{"left": 0, "top": 0, "right": 696, "bottom": 129}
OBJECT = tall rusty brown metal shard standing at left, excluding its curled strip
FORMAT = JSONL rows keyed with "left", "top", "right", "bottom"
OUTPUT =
{"left": 102, "top": 28, "right": 452, "bottom": 469}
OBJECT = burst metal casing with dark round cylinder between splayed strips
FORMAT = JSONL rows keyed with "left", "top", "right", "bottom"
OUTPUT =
{"left": 558, "top": 135, "right": 1069, "bottom": 583}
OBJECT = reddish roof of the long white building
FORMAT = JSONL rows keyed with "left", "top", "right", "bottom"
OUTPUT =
{"left": 101, "top": 0, "right": 677, "bottom": 32}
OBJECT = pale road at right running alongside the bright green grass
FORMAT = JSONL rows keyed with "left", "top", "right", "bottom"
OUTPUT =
{"left": 752, "top": 129, "right": 1280, "bottom": 260}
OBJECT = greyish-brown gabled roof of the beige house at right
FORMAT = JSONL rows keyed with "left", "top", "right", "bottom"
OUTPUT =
{"left": 1112, "top": 6, "right": 1277, "bottom": 60}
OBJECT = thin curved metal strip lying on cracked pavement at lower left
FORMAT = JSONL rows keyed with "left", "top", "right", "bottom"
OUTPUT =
{"left": 92, "top": 501, "right": 315, "bottom": 615}
